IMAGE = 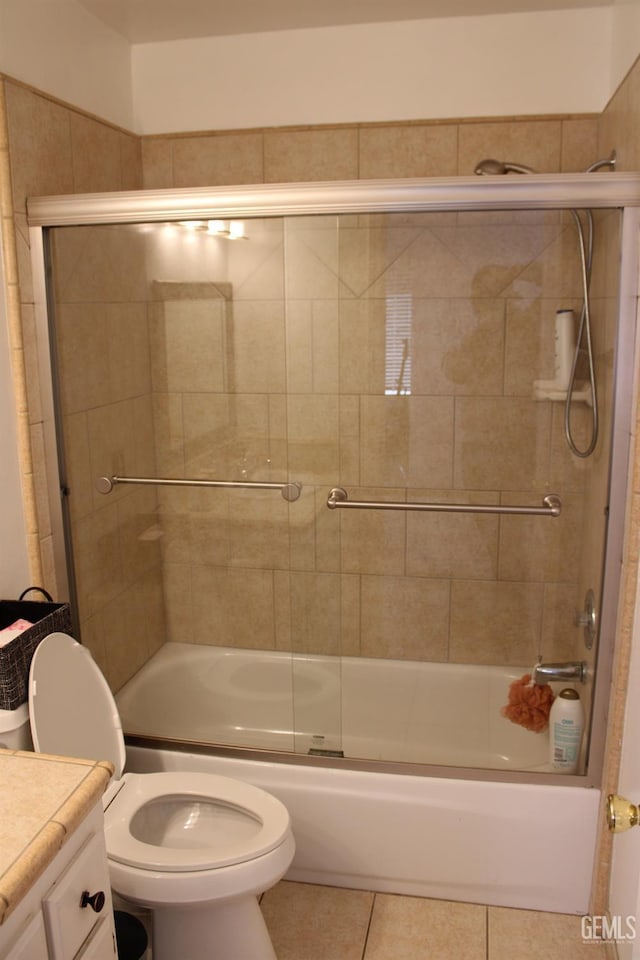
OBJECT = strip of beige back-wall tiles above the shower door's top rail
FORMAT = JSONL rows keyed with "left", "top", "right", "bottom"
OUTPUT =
{"left": 142, "top": 117, "right": 598, "bottom": 189}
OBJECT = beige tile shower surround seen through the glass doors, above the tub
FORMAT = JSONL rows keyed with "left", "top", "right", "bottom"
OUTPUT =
{"left": 47, "top": 201, "right": 610, "bottom": 684}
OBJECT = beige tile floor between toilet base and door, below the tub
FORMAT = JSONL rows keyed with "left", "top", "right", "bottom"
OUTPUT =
{"left": 260, "top": 880, "right": 613, "bottom": 960}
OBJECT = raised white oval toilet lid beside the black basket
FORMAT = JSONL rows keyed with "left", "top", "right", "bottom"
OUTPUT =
{"left": 29, "top": 633, "right": 125, "bottom": 779}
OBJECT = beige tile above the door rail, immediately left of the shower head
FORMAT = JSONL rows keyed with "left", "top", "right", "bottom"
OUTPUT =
{"left": 359, "top": 124, "right": 458, "bottom": 180}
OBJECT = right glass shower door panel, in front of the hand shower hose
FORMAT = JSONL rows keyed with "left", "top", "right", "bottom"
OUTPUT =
{"left": 292, "top": 211, "right": 617, "bottom": 770}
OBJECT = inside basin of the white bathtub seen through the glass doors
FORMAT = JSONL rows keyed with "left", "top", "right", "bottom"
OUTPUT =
{"left": 117, "top": 643, "right": 549, "bottom": 771}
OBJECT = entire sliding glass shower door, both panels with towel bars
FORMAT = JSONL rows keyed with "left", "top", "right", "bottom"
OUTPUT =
{"left": 42, "top": 199, "right": 619, "bottom": 771}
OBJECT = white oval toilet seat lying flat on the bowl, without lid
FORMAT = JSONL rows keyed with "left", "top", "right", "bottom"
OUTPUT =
{"left": 105, "top": 772, "right": 289, "bottom": 873}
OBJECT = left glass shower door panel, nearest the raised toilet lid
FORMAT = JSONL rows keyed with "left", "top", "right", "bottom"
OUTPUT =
{"left": 46, "top": 220, "right": 298, "bottom": 750}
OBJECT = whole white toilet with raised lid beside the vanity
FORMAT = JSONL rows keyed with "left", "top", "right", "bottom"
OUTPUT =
{"left": 29, "top": 633, "right": 295, "bottom": 960}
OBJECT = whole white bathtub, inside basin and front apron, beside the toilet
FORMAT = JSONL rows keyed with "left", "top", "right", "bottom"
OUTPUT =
{"left": 117, "top": 643, "right": 600, "bottom": 914}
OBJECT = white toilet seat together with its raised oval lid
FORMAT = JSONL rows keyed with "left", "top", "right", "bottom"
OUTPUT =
{"left": 29, "top": 633, "right": 290, "bottom": 873}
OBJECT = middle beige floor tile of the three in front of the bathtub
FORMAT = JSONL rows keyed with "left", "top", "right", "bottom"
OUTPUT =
{"left": 366, "top": 894, "right": 484, "bottom": 960}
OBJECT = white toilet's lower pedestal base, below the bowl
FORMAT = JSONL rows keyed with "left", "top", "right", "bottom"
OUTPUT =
{"left": 153, "top": 896, "right": 277, "bottom": 960}
